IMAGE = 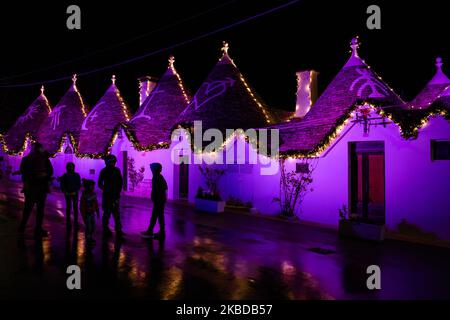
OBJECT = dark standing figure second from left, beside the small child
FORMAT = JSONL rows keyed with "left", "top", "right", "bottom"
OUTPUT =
{"left": 60, "top": 162, "right": 81, "bottom": 230}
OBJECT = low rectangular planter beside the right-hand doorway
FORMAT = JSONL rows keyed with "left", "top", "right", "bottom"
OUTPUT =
{"left": 339, "top": 205, "right": 386, "bottom": 242}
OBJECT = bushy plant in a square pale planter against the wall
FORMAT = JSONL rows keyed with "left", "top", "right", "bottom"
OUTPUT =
{"left": 195, "top": 166, "right": 225, "bottom": 213}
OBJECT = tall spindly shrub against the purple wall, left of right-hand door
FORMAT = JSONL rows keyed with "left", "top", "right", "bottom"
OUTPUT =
{"left": 273, "top": 158, "right": 317, "bottom": 220}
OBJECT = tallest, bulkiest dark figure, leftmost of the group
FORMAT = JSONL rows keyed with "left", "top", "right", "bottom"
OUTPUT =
{"left": 19, "top": 142, "right": 53, "bottom": 237}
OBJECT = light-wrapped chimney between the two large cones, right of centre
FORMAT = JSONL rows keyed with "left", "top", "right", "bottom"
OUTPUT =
{"left": 295, "top": 70, "right": 318, "bottom": 118}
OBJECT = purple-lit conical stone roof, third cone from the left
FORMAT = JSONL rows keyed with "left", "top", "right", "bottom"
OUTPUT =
{"left": 77, "top": 76, "right": 130, "bottom": 156}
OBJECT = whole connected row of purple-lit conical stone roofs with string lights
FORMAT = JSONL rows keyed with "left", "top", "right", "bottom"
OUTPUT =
{"left": 0, "top": 39, "right": 450, "bottom": 158}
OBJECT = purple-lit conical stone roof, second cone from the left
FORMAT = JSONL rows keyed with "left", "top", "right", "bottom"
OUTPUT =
{"left": 37, "top": 75, "right": 87, "bottom": 156}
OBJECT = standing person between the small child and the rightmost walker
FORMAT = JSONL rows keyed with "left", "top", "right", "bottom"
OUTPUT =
{"left": 98, "top": 154, "right": 125, "bottom": 237}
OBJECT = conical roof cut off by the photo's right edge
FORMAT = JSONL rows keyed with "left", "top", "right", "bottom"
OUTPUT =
{"left": 409, "top": 57, "right": 450, "bottom": 109}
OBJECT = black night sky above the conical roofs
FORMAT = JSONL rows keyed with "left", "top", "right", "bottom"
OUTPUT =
{"left": 0, "top": 0, "right": 450, "bottom": 130}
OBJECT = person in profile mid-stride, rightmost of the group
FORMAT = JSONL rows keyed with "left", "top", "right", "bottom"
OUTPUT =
{"left": 141, "top": 163, "right": 167, "bottom": 239}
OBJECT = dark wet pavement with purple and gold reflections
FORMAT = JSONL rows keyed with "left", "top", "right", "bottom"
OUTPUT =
{"left": 0, "top": 183, "right": 450, "bottom": 299}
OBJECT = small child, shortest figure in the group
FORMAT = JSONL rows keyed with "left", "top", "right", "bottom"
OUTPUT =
{"left": 80, "top": 179, "right": 100, "bottom": 244}
